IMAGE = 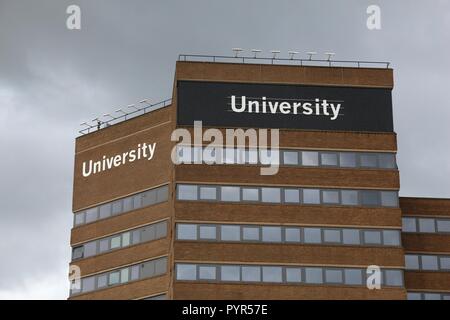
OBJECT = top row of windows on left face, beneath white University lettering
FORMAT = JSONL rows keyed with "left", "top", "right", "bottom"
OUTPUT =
{"left": 74, "top": 185, "right": 169, "bottom": 226}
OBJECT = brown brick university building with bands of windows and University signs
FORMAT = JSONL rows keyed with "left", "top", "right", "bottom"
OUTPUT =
{"left": 69, "top": 57, "right": 450, "bottom": 300}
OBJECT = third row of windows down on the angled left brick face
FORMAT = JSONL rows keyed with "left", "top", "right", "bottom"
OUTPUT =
{"left": 70, "top": 257, "right": 167, "bottom": 295}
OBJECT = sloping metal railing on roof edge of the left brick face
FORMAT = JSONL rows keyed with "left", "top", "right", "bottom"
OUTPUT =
{"left": 78, "top": 98, "right": 172, "bottom": 135}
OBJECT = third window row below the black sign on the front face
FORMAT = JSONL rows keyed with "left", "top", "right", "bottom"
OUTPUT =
{"left": 176, "top": 223, "right": 400, "bottom": 246}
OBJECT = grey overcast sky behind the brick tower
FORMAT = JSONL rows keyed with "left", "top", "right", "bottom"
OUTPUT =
{"left": 0, "top": 0, "right": 450, "bottom": 299}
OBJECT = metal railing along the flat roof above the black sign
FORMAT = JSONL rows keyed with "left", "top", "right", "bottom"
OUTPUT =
{"left": 178, "top": 54, "right": 390, "bottom": 69}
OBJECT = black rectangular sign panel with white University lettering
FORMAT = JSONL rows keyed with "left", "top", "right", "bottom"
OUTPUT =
{"left": 177, "top": 81, "right": 393, "bottom": 132}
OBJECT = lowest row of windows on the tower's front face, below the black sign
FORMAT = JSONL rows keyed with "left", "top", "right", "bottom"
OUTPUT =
{"left": 176, "top": 263, "right": 403, "bottom": 287}
